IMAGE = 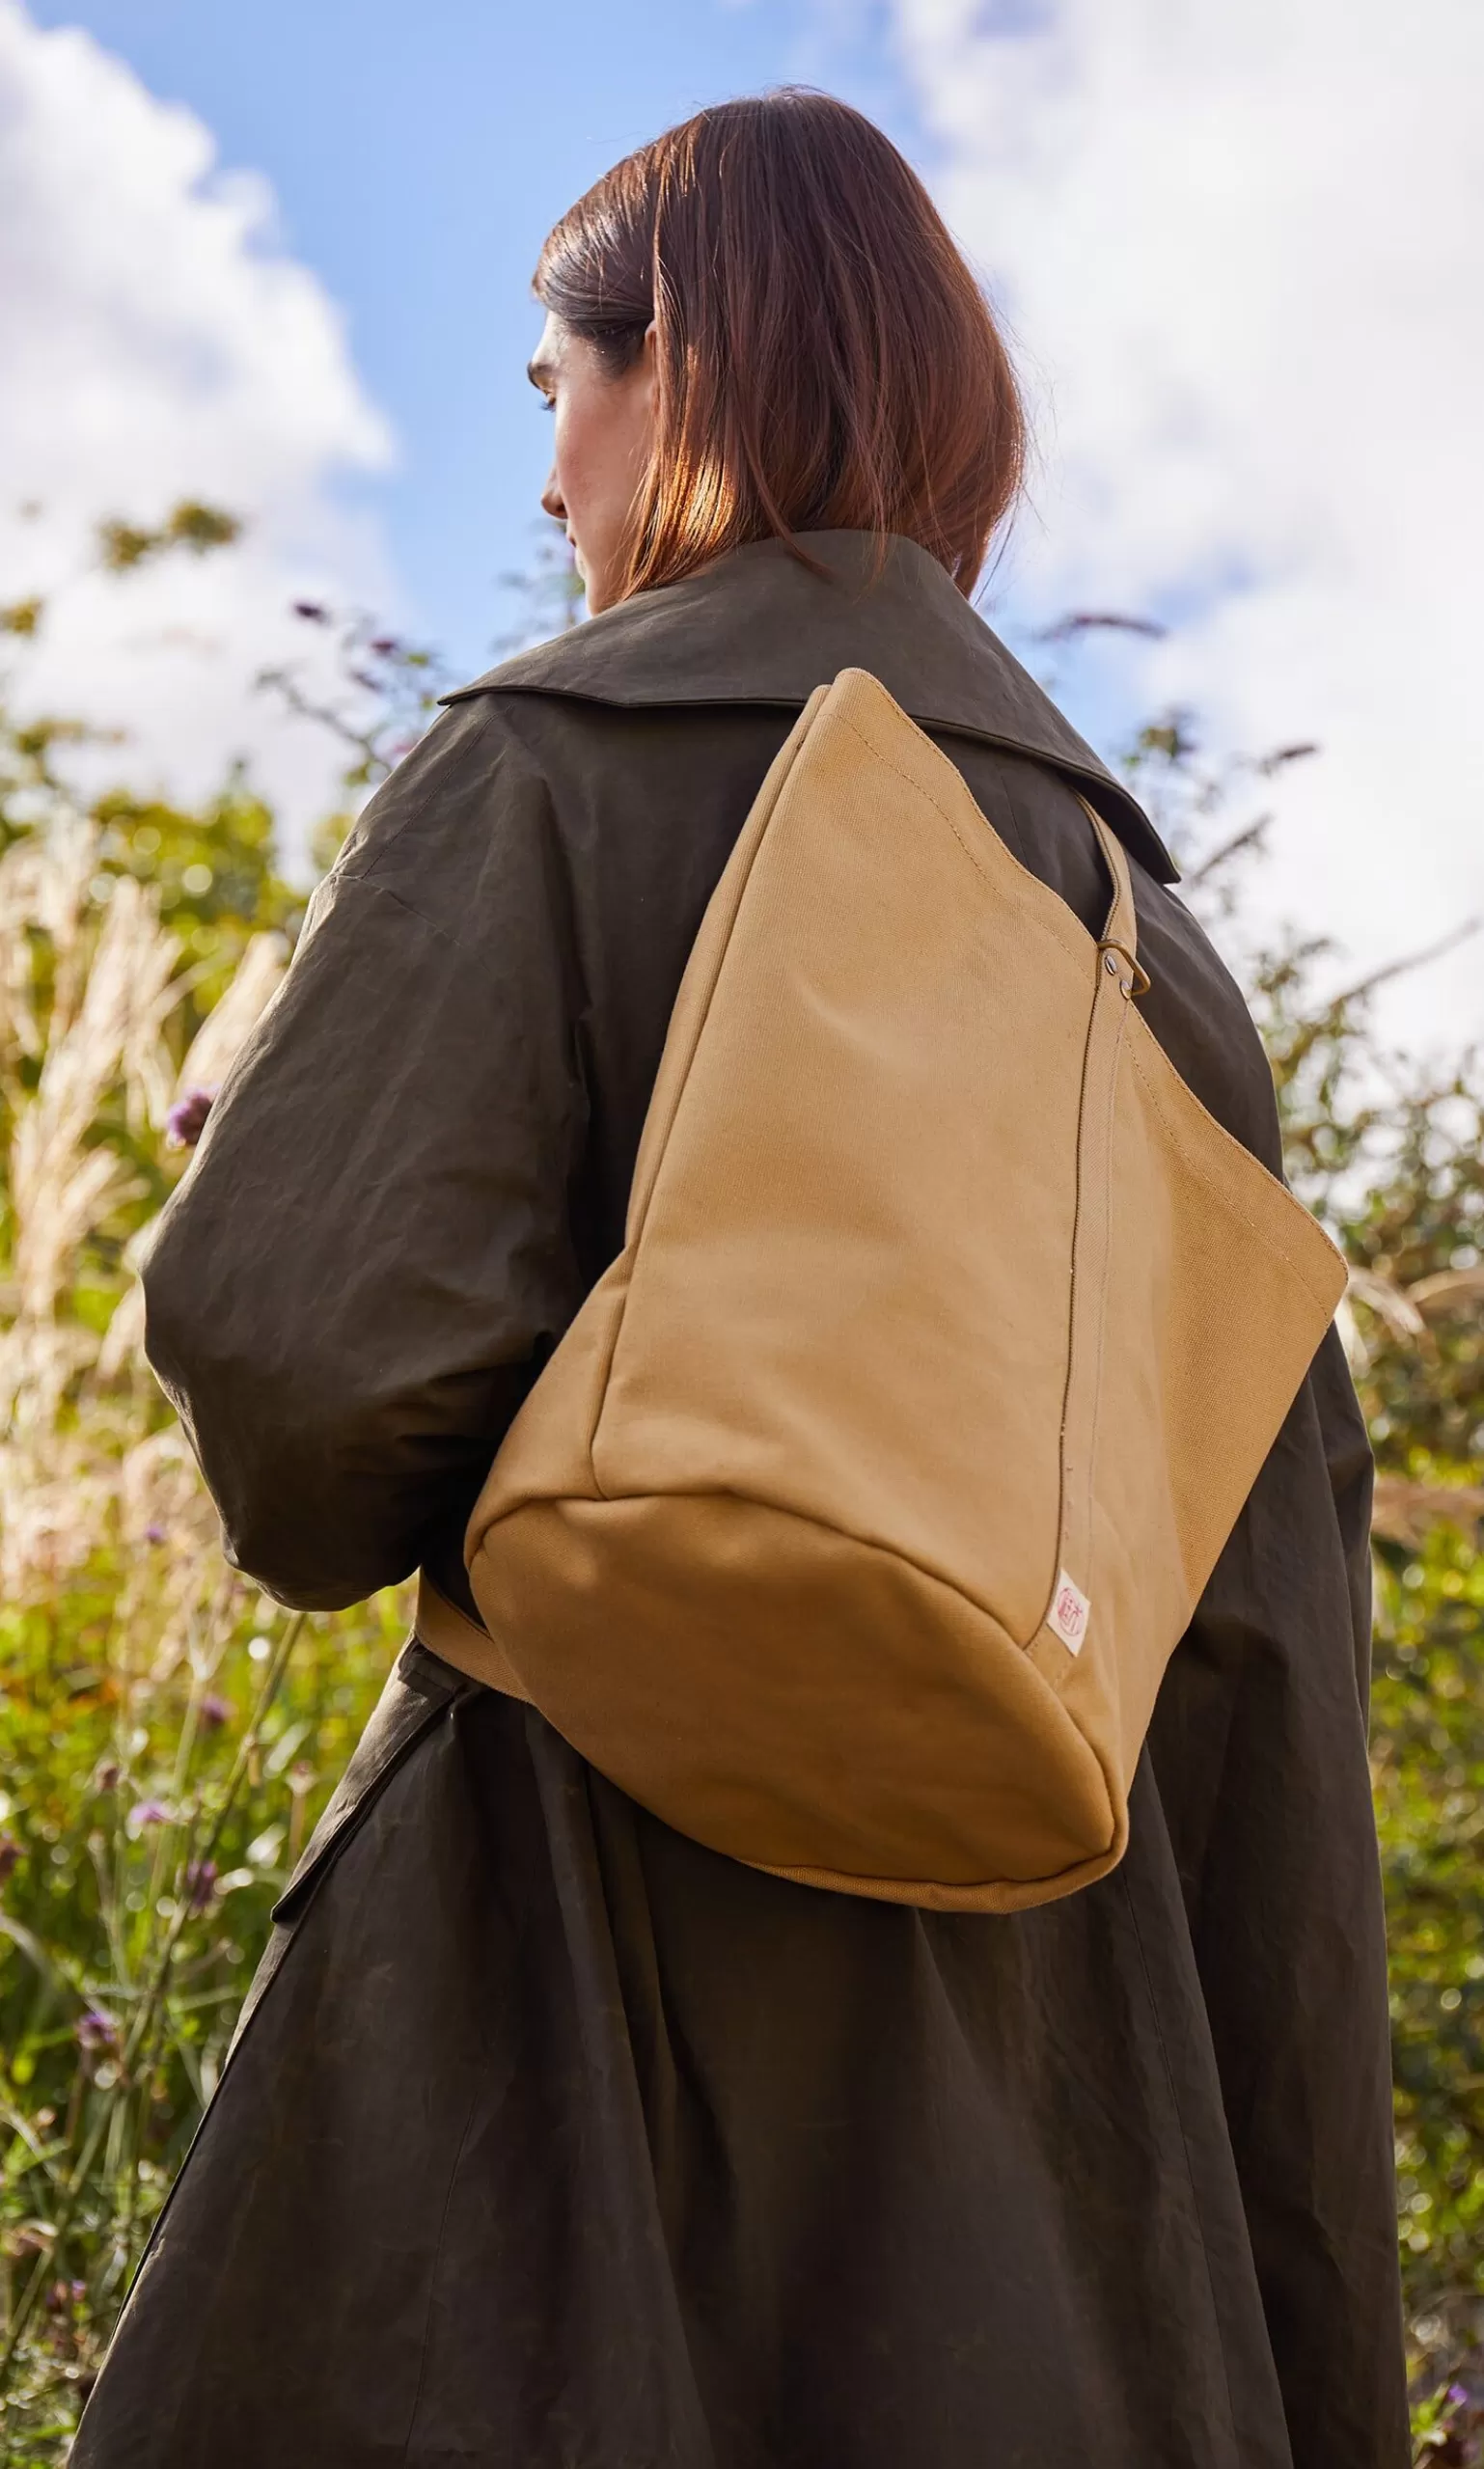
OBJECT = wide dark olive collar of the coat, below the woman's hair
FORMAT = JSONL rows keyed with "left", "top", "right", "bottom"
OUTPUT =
{"left": 445, "top": 531, "right": 1178, "bottom": 884}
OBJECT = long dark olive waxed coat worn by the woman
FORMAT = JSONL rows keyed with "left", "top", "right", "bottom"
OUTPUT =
{"left": 74, "top": 534, "right": 1408, "bottom": 2469}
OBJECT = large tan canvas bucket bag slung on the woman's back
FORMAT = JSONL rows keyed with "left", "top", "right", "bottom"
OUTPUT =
{"left": 420, "top": 669, "right": 1343, "bottom": 1911}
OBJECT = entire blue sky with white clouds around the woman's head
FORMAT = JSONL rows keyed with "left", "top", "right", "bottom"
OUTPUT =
{"left": 0, "top": 0, "right": 1484, "bottom": 1042}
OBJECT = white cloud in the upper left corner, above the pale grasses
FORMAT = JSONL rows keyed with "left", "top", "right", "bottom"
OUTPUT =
{"left": 0, "top": 0, "right": 393, "bottom": 849}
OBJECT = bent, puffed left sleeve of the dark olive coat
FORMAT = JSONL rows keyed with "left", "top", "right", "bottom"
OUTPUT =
{"left": 143, "top": 699, "right": 585, "bottom": 1609}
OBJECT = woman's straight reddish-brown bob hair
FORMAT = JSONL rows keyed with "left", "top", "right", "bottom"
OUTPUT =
{"left": 536, "top": 87, "right": 1025, "bottom": 597}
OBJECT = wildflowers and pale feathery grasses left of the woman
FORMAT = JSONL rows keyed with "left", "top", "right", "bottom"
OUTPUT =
{"left": 0, "top": 526, "right": 405, "bottom": 2469}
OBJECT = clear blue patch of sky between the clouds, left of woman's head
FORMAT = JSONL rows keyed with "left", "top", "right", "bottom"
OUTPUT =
{"left": 30, "top": 0, "right": 921, "bottom": 669}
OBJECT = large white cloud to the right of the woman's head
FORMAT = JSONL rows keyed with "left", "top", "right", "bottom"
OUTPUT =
{"left": 892, "top": 0, "right": 1484, "bottom": 1042}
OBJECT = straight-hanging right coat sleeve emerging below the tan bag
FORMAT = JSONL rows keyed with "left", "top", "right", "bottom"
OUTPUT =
{"left": 1151, "top": 1329, "right": 1410, "bottom": 2469}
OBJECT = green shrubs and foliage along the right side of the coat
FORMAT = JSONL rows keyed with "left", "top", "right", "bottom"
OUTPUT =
{"left": 1128, "top": 716, "right": 1484, "bottom": 2409}
